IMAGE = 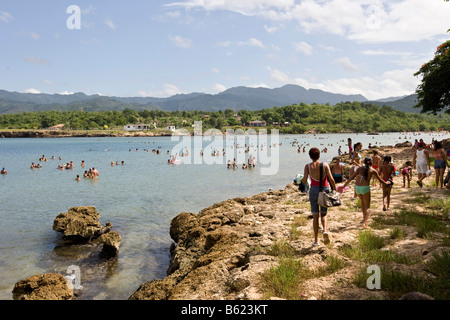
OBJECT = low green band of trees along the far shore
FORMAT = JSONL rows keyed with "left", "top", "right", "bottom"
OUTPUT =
{"left": 0, "top": 102, "right": 450, "bottom": 133}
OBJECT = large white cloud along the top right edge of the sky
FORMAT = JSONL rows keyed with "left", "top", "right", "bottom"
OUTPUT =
{"left": 167, "top": 0, "right": 450, "bottom": 43}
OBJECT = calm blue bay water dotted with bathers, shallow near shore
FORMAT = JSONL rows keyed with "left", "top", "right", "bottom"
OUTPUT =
{"left": 0, "top": 133, "right": 449, "bottom": 299}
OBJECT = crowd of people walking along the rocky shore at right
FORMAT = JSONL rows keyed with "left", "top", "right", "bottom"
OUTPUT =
{"left": 299, "top": 138, "right": 450, "bottom": 246}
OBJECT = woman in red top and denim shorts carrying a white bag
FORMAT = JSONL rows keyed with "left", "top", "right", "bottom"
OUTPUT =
{"left": 302, "top": 148, "right": 336, "bottom": 246}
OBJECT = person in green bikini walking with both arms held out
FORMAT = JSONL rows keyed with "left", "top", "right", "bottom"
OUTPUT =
{"left": 338, "top": 157, "right": 389, "bottom": 229}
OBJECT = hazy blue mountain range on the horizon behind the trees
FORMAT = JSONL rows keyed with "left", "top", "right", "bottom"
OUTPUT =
{"left": 0, "top": 85, "right": 419, "bottom": 114}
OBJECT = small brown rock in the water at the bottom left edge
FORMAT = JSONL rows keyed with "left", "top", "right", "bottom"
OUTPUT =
{"left": 12, "top": 273, "right": 75, "bottom": 300}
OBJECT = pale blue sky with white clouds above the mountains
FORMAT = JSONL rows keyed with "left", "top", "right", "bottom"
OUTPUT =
{"left": 0, "top": 0, "right": 450, "bottom": 100}
